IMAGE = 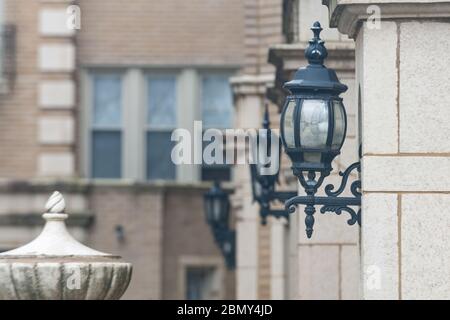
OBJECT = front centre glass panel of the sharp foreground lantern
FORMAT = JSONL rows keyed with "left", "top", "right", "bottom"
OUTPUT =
{"left": 300, "top": 99, "right": 329, "bottom": 149}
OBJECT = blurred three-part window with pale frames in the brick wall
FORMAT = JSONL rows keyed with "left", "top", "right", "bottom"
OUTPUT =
{"left": 85, "top": 68, "right": 237, "bottom": 181}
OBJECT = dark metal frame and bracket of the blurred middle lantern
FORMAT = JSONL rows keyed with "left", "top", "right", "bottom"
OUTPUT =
{"left": 250, "top": 104, "right": 297, "bottom": 225}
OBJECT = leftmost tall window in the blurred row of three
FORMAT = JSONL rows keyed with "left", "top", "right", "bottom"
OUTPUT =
{"left": 91, "top": 74, "right": 122, "bottom": 178}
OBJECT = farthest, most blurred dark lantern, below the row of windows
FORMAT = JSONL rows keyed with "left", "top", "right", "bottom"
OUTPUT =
{"left": 204, "top": 181, "right": 236, "bottom": 269}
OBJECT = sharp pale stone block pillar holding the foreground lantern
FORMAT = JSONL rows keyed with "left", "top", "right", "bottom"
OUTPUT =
{"left": 323, "top": 0, "right": 450, "bottom": 299}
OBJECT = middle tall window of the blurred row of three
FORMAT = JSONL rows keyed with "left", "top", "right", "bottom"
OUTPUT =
{"left": 146, "top": 75, "right": 177, "bottom": 180}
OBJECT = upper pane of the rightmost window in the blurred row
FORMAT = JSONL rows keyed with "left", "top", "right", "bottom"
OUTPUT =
{"left": 202, "top": 75, "right": 233, "bottom": 129}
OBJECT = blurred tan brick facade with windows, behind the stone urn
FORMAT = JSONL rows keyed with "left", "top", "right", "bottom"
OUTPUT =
{"left": 0, "top": 0, "right": 244, "bottom": 299}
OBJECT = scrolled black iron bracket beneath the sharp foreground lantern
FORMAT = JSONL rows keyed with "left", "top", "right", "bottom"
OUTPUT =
{"left": 285, "top": 162, "right": 361, "bottom": 238}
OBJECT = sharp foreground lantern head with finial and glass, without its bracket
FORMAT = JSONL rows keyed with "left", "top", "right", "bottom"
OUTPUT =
{"left": 281, "top": 22, "right": 347, "bottom": 175}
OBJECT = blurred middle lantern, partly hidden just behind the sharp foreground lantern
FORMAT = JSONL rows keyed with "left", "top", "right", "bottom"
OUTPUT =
{"left": 250, "top": 104, "right": 297, "bottom": 225}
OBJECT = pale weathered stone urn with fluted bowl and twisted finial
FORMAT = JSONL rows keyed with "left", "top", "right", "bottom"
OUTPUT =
{"left": 0, "top": 192, "right": 132, "bottom": 300}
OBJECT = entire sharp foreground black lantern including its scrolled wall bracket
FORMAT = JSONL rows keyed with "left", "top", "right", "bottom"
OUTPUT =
{"left": 280, "top": 22, "right": 361, "bottom": 238}
